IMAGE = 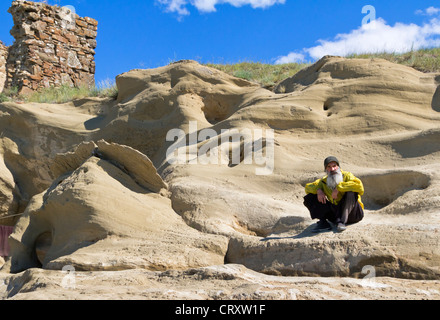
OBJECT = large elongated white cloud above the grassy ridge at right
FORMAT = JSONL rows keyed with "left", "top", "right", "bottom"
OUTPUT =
{"left": 275, "top": 13, "right": 440, "bottom": 64}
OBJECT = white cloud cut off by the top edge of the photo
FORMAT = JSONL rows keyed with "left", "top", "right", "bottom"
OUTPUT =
{"left": 156, "top": 0, "right": 286, "bottom": 15}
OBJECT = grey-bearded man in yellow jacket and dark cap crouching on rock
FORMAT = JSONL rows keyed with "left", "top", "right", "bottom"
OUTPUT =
{"left": 304, "top": 157, "right": 364, "bottom": 233}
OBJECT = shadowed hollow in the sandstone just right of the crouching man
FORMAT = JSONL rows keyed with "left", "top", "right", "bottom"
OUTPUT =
{"left": 360, "top": 171, "right": 430, "bottom": 210}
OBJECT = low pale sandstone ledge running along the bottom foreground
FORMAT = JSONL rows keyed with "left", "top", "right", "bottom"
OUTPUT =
{"left": 0, "top": 264, "right": 440, "bottom": 300}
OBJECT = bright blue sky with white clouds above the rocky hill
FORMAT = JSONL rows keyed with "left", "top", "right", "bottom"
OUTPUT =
{"left": 0, "top": 0, "right": 440, "bottom": 82}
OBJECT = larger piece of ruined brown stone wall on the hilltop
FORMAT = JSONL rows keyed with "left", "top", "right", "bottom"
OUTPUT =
{"left": 0, "top": 0, "right": 98, "bottom": 94}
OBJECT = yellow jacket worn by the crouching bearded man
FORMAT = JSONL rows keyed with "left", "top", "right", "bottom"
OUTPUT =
{"left": 306, "top": 170, "right": 364, "bottom": 209}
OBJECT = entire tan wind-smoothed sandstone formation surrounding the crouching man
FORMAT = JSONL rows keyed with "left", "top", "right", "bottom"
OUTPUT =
{"left": 0, "top": 57, "right": 440, "bottom": 299}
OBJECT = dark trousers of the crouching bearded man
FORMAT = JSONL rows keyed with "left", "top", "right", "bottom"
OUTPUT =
{"left": 304, "top": 192, "right": 364, "bottom": 224}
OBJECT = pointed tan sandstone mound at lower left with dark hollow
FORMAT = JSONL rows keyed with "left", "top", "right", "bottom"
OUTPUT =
{"left": 10, "top": 149, "right": 228, "bottom": 272}
